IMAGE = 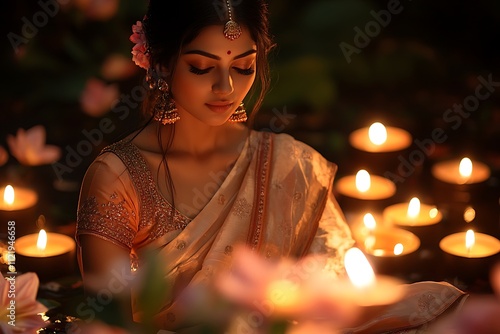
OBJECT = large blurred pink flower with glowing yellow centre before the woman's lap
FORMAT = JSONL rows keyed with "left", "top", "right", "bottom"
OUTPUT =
{"left": 216, "top": 248, "right": 359, "bottom": 328}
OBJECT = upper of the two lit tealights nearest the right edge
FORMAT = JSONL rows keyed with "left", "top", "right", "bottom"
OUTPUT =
{"left": 432, "top": 157, "right": 490, "bottom": 184}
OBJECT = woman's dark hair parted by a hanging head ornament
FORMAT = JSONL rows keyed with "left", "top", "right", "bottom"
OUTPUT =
{"left": 143, "top": 0, "right": 273, "bottom": 119}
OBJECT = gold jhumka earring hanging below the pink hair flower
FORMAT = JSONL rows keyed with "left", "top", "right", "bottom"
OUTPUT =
{"left": 146, "top": 69, "right": 181, "bottom": 125}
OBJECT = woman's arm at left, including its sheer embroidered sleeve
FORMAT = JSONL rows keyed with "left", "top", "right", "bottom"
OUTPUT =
{"left": 76, "top": 153, "right": 137, "bottom": 324}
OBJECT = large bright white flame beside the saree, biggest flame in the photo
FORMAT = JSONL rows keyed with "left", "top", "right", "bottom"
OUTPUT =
{"left": 344, "top": 247, "right": 375, "bottom": 288}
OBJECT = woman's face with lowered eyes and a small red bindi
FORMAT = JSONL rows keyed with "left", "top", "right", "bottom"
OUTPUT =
{"left": 171, "top": 26, "right": 257, "bottom": 126}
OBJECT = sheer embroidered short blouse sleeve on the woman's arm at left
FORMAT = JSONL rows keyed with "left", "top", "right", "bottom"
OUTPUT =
{"left": 76, "top": 152, "right": 139, "bottom": 249}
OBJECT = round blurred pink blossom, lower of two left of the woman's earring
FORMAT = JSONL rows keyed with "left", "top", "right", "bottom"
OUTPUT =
{"left": 80, "top": 78, "right": 120, "bottom": 117}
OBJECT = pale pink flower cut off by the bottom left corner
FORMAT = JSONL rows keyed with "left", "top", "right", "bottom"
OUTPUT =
{"left": 0, "top": 273, "right": 47, "bottom": 334}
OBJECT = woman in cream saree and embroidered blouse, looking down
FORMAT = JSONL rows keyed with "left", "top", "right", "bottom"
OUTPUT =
{"left": 77, "top": 0, "right": 474, "bottom": 331}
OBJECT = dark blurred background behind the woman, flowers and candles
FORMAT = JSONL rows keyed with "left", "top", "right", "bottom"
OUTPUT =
{"left": 0, "top": 0, "right": 500, "bottom": 290}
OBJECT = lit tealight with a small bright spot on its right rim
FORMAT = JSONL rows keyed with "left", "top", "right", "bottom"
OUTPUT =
{"left": 382, "top": 197, "right": 443, "bottom": 226}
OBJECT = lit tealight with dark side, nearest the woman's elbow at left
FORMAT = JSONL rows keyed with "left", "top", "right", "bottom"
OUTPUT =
{"left": 16, "top": 229, "right": 76, "bottom": 281}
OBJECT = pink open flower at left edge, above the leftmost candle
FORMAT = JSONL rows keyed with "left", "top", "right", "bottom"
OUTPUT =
{"left": 7, "top": 125, "right": 61, "bottom": 166}
